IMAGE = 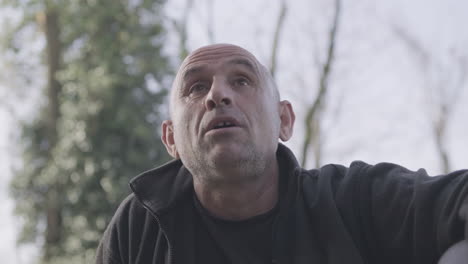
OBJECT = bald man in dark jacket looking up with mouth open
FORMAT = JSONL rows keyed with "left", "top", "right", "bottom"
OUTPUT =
{"left": 97, "top": 44, "right": 468, "bottom": 264}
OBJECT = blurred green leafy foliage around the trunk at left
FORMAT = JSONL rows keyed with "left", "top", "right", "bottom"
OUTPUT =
{"left": 6, "top": 0, "right": 170, "bottom": 263}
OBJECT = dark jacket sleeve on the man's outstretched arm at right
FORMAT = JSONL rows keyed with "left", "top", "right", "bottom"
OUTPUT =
{"left": 364, "top": 163, "right": 468, "bottom": 264}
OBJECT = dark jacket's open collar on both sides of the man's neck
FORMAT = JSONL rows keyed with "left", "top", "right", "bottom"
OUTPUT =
{"left": 130, "top": 143, "right": 299, "bottom": 215}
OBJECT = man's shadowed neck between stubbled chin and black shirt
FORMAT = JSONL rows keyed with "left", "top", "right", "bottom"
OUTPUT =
{"left": 194, "top": 161, "right": 279, "bottom": 220}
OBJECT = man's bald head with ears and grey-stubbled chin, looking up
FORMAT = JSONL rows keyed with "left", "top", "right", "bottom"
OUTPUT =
{"left": 163, "top": 45, "right": 292, "bottom": 182}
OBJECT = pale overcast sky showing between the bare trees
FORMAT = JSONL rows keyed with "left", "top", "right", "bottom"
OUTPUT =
{"left": 0, "top": 0, "right": 468, "bottom": 264}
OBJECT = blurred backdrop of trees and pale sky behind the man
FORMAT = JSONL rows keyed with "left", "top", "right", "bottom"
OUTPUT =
{"left": 0, "top": 0, "right": 468, "bottom": 264}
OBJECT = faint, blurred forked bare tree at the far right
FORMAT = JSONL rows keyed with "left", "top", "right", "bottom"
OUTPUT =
{"left": 393, "top": 25, "right": 468, "bottom": 173}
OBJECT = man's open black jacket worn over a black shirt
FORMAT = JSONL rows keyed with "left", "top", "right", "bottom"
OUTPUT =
{"left": 96, "top": 144, "right": 468, "bottom": 264}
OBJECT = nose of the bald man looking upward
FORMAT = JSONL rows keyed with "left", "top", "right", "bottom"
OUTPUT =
{"left": 205, "top": 78, "right": 232, "bottom": 110}
